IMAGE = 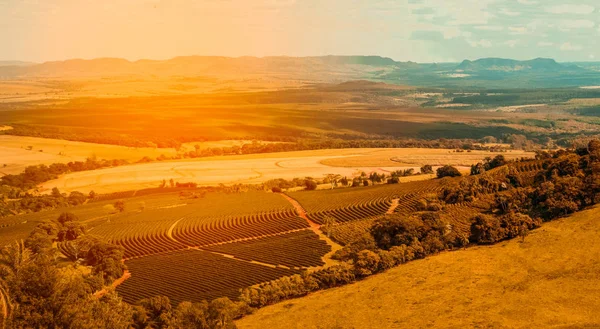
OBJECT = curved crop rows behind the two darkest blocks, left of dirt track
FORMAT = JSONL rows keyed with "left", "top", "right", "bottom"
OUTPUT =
{"left": 86, "top": 192, "right": 298, "bottom": 258}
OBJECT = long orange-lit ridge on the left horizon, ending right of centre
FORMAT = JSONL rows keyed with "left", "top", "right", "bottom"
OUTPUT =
{"left": 0, "top": 56, "right": 400, "bottom": 79}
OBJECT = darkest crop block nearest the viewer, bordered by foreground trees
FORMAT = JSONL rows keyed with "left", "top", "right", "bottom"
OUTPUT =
{"left": 117, "top": 250, "right": 300, "bottom": 305}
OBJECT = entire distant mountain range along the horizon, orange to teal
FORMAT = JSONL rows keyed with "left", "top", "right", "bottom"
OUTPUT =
{"left": 0, "top": 56, "right": 600, "bottom": 89}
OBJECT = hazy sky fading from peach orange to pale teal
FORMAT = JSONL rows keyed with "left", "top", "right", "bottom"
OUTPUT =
{"left": 0, "top": 0, "right": 600, "bottom": 62}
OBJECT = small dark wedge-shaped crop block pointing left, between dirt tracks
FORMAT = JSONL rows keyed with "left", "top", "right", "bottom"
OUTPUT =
{"left": 204, "top": 229, "right": 331, "bottom": 268}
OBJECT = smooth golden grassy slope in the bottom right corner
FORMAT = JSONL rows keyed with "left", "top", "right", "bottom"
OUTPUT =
{"left": 237, "top": 208, "right": 600, "bottom": 328}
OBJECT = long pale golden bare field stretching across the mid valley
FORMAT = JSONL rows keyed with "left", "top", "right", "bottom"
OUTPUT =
{"left": 40, "top": 149, "right": 533, "bottom": 193}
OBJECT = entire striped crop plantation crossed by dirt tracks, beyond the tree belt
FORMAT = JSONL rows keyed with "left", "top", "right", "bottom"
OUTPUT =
{"left": 0, "top": 172, "right": 450, "bottom": 303}
